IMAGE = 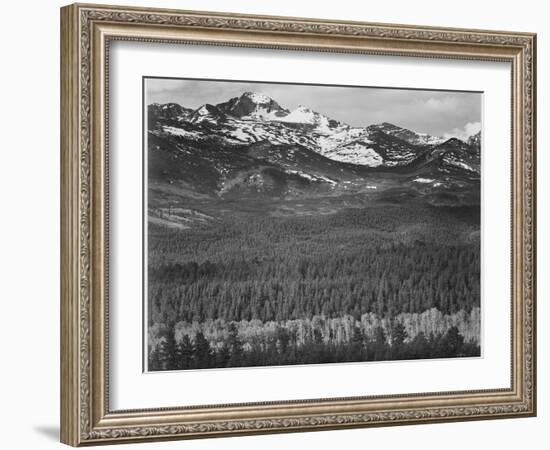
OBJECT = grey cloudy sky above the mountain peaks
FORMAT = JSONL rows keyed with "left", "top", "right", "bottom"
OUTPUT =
{"left": 145, "top": 78, "right": 482, "bottom": 138}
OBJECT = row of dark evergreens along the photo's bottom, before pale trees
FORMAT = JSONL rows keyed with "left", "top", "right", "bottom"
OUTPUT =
{"left": 148, "top": 321, "right": 480, "bottom": 371}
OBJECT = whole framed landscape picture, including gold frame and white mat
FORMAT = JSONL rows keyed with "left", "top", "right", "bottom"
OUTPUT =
{"left": 61, "top": 4, "right": 536, "bottom": 446}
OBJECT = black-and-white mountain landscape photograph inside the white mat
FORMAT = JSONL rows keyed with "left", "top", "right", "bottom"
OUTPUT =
{"left": 143, "top": 77, "right": 483, "bottom": 372}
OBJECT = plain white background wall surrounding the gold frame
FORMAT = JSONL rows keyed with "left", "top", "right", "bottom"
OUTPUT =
{"left": 0, "top": 0, "right": 550, "bottom": 450}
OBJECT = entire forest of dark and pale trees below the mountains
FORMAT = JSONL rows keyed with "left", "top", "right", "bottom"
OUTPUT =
{"left": 147, "top": 203, "right": 480, "bottom": 370}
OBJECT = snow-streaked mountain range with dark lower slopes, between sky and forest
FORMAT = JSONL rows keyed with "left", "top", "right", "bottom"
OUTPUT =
{"left": 148, "top": 92, "right": 480, "bottom": 197}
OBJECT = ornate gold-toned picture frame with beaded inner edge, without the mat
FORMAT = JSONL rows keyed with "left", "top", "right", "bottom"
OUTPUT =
{"left": 61, "top": 4, "right": 536, "bottom": 446}
